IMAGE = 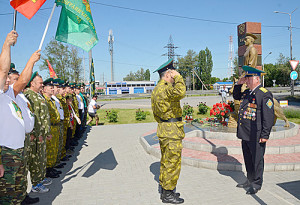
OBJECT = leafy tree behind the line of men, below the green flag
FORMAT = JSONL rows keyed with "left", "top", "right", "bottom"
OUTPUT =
{"left": 39, "top": 39, "right": 82, "bottom": 82}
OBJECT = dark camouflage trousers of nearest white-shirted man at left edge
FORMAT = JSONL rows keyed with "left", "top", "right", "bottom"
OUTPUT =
{"left": 0, "top": 147, "right": 27, "bottom": 205}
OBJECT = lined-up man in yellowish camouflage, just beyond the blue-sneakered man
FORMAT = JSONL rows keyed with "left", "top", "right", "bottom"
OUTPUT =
{"left": 43, "top": 78, "right": 61, "bottom": 177}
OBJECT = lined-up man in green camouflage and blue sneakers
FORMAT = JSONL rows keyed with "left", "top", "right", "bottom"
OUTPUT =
{"left": 24, "top": 72, "right": 52, "bottom": 193}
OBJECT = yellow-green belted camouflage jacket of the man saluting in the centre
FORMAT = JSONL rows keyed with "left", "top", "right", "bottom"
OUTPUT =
{"left": 151, "top": 75, "right": 186, "bottom": 139}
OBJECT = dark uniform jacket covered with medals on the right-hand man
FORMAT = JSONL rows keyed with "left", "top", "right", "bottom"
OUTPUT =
{"left": 233, "top": 85, "right": 274, "bottom": 141}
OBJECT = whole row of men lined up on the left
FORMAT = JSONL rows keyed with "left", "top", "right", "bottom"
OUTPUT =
{"left": 0, "top": 31, "right": 88, "bottom": 204}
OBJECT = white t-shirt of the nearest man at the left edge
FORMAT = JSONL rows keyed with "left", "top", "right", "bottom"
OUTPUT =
{"left": 0, "top": 92, "right": 25, "bottom": 149}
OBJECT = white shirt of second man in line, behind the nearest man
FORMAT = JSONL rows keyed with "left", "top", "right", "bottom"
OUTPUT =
{"left": 5, "top": 85, "right": 34, "bottom": 133}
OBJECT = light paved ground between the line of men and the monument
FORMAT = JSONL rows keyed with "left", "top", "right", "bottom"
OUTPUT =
{"left": 31, "top": 123, "right": 300, "bottom": 205}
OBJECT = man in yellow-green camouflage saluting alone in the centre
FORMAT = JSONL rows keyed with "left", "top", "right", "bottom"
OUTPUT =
{"left": 151, "top": 59, "right": 186, "bottom": 204}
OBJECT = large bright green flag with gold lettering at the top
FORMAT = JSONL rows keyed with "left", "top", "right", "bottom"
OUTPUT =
{"left": 55, "top": 0, "right": 98, "bottom": 52}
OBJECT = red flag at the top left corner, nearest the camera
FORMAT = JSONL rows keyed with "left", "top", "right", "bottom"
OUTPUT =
{"left": 10, "top": 0, "right": 46, "bottom": 19}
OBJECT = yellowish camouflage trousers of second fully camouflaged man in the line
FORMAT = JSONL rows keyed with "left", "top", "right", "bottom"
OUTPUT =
{"left": 46, "top": 125, "right": 60, "bottom": 168}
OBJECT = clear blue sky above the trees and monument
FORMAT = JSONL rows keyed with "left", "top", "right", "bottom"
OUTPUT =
{"left": 0, "top": 0, "right": 300, "bottom": 83}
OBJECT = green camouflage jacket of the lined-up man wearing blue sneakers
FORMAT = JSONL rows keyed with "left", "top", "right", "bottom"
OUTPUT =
{"left": 24, "top": 88, "right": 50, "bottom": 138}
